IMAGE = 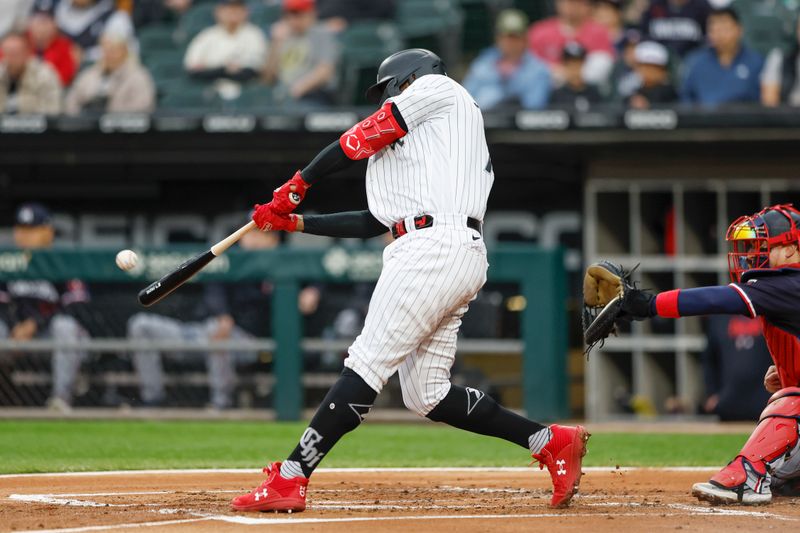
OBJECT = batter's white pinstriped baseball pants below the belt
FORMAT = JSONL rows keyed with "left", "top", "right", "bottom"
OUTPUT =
{"left": 344, "top": 215, "right": 489, "bottom": 416}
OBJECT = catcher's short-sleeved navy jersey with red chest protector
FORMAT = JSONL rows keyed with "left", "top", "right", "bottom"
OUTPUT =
{"left": 730, "top": 265, "right": 800, "bottom": 387}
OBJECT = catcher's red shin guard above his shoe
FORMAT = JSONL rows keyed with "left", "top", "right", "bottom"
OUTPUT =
{"left": 711, "top": 387, "right": 800, "bottom": 489}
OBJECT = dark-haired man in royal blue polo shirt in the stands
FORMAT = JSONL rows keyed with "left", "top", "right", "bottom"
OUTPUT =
{"left": 681, "top": 8, "right": 764, "bottom": 106}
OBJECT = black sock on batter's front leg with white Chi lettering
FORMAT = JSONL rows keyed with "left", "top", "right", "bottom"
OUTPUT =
{"left": 289, "top": 368, "right": 378, "bottom": 477}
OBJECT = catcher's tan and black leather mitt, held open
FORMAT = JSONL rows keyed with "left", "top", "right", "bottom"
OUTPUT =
{"left": 583, "top": 261, "right": 654, "bottom": 354}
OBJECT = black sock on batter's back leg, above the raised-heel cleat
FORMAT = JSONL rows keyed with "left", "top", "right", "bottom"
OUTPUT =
{"left": 428, "top": 385, "right": 545, "bottom": 449}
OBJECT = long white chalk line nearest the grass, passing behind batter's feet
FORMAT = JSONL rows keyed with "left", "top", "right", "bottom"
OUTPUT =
{"left": 0, "top": 466, "right": 719, "bottom": 479}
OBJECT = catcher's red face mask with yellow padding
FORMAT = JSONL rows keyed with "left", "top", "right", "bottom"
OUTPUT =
{"left": 725, "top": 204, "right": 800, "bottom": 282}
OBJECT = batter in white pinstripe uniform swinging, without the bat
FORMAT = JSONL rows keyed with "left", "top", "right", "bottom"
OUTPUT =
{"left": 232, "top": 49, "right": 589, "bottom": 511}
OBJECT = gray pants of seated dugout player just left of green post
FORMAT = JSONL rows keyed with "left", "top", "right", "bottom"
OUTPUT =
{"left": 128, "top": 313, "right": 250, "bottom": 408}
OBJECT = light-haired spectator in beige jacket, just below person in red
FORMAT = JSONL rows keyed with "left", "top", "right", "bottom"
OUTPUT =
{"left": 65, "top": 24, "right": 155, "bottom": 115}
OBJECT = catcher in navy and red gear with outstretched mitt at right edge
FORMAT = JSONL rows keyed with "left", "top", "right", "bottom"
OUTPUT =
{"left": 584, "top": 204, "right": 800, "bottom": 505}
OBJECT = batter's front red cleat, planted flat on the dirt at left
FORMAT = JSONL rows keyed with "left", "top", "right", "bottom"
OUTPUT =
{"left": 231, "top": 462, "right": 308, "bottom": 513}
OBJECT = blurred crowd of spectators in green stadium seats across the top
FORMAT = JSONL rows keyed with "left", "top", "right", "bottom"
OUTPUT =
{"left": 0, "top": 0, "right": 800, "bottom": 115}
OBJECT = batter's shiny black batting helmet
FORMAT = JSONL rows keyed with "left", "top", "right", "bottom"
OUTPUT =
{"left": 366, "top": 48, "right": 447, "bottom": 104}
